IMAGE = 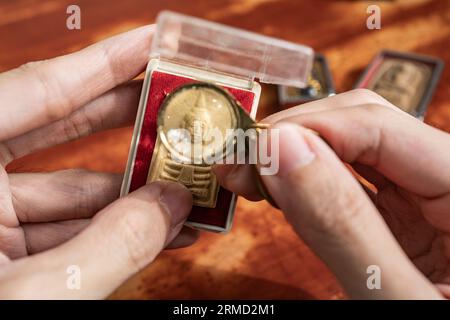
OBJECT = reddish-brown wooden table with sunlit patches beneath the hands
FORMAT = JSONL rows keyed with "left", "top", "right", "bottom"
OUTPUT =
{"left": 0, "top": 0, "right": 450, "bottom": 299}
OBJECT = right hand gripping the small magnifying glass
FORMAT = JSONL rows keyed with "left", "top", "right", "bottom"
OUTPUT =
{"left": 215, "top": 90, "right": 450, "bottom": 299}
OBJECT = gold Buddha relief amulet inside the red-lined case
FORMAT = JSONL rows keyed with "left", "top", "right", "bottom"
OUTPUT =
{"left": 147, "top": 83, "right": 237, "bottom": 207}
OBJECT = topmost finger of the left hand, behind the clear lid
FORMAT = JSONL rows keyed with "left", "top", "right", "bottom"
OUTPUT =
{"left": 0, "top": 26, "right": 153, "bottom": 140}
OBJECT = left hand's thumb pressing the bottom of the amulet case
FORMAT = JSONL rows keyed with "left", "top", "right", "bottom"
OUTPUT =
{"left": 0, "top": 182, "right": 192, "bottom": 299}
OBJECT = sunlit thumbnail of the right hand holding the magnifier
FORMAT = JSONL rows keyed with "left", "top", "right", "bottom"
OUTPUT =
{"left": 272, "top": 122, "right": 316, "bottom": 177}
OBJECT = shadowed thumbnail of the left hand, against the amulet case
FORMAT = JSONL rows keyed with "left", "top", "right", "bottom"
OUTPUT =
{"left": 159, "top": 182, "right": 192, "bottom": 227}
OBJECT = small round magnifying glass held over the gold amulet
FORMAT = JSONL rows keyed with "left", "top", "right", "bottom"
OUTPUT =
{"left": 158, "top": 82, "right": 275, "bottom": 205}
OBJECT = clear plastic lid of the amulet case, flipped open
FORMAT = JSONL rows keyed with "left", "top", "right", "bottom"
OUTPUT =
{"left": 151, "top": 11, "right": 314, "bottom": 87}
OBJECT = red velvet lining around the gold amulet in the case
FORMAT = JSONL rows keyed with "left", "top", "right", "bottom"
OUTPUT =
{"left": 129, "top": 71, "right": 255, "bottom": 227}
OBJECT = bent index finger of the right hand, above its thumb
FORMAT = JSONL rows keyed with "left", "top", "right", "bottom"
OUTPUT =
{"left": 283, "top": 105, "right": 450, "bottom": 197}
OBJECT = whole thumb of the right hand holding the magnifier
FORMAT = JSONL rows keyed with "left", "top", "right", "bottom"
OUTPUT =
{"left": 262, "top": 122, "right": 439, "bottom": 298}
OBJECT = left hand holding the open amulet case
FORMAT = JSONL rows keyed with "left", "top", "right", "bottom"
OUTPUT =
{"left": 0, "top": 26, "right": 197, "bottom": 299}
